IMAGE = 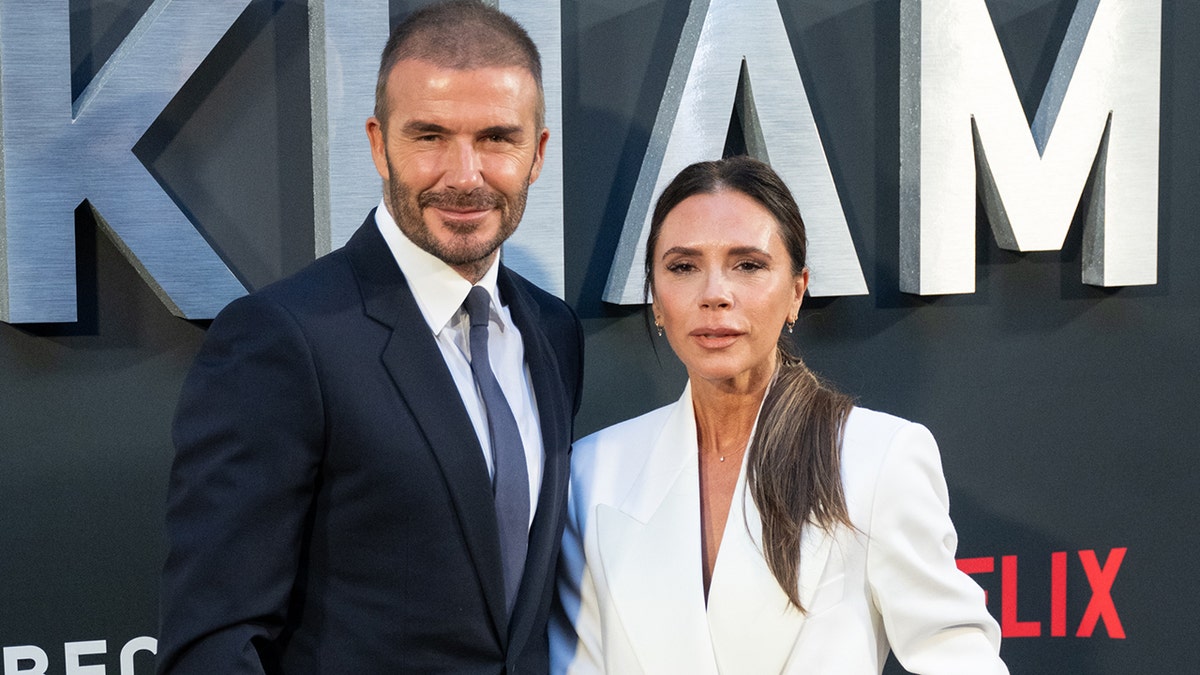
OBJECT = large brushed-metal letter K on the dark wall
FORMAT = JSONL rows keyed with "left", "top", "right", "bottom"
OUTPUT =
{"left": 0, "top": 0, "right": 248, "bottom": 323}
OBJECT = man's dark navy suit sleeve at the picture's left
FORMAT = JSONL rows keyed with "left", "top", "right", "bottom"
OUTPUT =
{"left": 158, "top": 295, "right": 323, "bottom": 674}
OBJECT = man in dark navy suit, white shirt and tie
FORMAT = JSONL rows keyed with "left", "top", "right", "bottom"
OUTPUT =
{"left": 158, "top": 1, "right": 582, "bottom": 674}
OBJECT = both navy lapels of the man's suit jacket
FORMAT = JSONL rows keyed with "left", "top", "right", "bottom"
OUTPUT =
{"left": 346, "top": 222, "right": 574, "bottom": 653}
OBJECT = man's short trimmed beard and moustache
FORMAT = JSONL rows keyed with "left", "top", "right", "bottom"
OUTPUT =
{"left": 386, "top": 156, "right": 529, "bottom": 273}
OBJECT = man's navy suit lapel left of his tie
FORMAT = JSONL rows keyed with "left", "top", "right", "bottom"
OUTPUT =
{"left": 346, "top": 218, "right": 508, "bottom": 643}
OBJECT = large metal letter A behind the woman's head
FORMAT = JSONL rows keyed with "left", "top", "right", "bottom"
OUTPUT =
{"left": 604, "top": 0, "right": 866, "bottom": 305}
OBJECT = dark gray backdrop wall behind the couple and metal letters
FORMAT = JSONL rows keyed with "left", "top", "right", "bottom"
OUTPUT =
{"left": 0, "top": 0, "right": 1200, "bottom": 675}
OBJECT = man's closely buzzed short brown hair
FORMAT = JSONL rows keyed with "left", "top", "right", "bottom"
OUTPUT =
{"left": 374, "top": 0, "right": 546, "bottom": 130}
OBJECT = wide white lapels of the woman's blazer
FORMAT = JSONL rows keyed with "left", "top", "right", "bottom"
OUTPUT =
{"left": 595, "top": 384, "right": 830, "bottom": 673}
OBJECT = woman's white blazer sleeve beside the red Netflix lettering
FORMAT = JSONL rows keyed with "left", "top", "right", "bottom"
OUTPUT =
{"left": 866, "top": 424, "right": 1008, "bottom": 675}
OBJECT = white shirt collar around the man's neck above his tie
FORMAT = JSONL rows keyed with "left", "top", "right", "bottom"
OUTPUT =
{"left": 376, "top": 201, "right": 506, "bottom": 334}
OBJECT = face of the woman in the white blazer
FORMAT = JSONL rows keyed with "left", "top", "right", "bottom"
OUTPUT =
{"left": 653, "top": 190, "right": 808, "bottom": 387}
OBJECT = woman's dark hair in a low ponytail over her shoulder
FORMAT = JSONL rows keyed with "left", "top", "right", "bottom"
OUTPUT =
{"left": 646, "top": 156, "right": 854, "bottom": 611}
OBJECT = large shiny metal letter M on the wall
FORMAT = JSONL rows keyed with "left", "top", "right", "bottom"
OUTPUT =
{"left": 900, "top": 0, "right": 1162, "bottom": 295}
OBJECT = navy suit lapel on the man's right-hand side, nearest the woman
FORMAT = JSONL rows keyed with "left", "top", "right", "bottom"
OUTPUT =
{"left": 497, "top": 267, "right": 571, "bottom": 651}
